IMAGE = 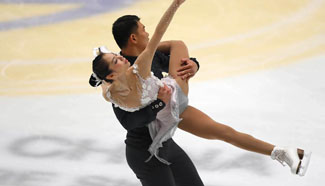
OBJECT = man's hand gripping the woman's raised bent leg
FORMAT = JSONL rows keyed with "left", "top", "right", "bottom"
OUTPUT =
{"left": 177, "top": 58, "right": 198, "bottom": 80}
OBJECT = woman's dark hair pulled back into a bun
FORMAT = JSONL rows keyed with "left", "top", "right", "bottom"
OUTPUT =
{"left": 89, "top": 53, "right": 113, "bottom": 87}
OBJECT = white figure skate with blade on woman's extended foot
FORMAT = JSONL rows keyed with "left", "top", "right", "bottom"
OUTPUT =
{"left": 271, "top": 147, "right": 311, "bottom": 176}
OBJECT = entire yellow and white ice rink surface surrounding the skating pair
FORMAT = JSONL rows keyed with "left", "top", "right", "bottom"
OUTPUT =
{"left": 0, "top": 0, "right": 325, "bottom": 186}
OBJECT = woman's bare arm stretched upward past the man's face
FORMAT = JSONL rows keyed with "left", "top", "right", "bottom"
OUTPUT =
{"left": 135, "top": 0, "right": 185, "bottom": 78}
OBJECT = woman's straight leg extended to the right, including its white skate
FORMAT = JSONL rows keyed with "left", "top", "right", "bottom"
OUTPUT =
{"left": 178, "top": 106, "right": 311, "bottom": 176}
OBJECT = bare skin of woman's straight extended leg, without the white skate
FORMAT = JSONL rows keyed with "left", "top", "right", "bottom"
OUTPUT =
{"left": 178, "top": 106, "right": 274, "bottom": 155}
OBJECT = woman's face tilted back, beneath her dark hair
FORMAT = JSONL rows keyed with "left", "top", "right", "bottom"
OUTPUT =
{"left": 103, "top": 53, "right": 130, "bottom": 75}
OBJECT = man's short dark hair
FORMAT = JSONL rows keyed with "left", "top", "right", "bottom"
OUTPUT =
{"left": 112, "top": 15, "right": 140, "bottom": 49}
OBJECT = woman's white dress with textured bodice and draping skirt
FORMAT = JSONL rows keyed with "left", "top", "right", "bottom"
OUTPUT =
{"left": 106, "top": 64, "right": 188, "bottom": 164}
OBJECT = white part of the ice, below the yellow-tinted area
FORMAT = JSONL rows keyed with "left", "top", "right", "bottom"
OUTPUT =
{"left": 0, "top": 56, "right": 325, "bottom": 186}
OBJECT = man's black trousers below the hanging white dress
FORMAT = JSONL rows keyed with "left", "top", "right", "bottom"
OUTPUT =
{"left": 126, "top": 139, "right": 203, "bottom": 186}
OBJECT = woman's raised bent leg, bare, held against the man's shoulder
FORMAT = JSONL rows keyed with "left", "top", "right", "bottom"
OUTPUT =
{"left": 169, "top": 41, "right": 189, "bottom": 95}
